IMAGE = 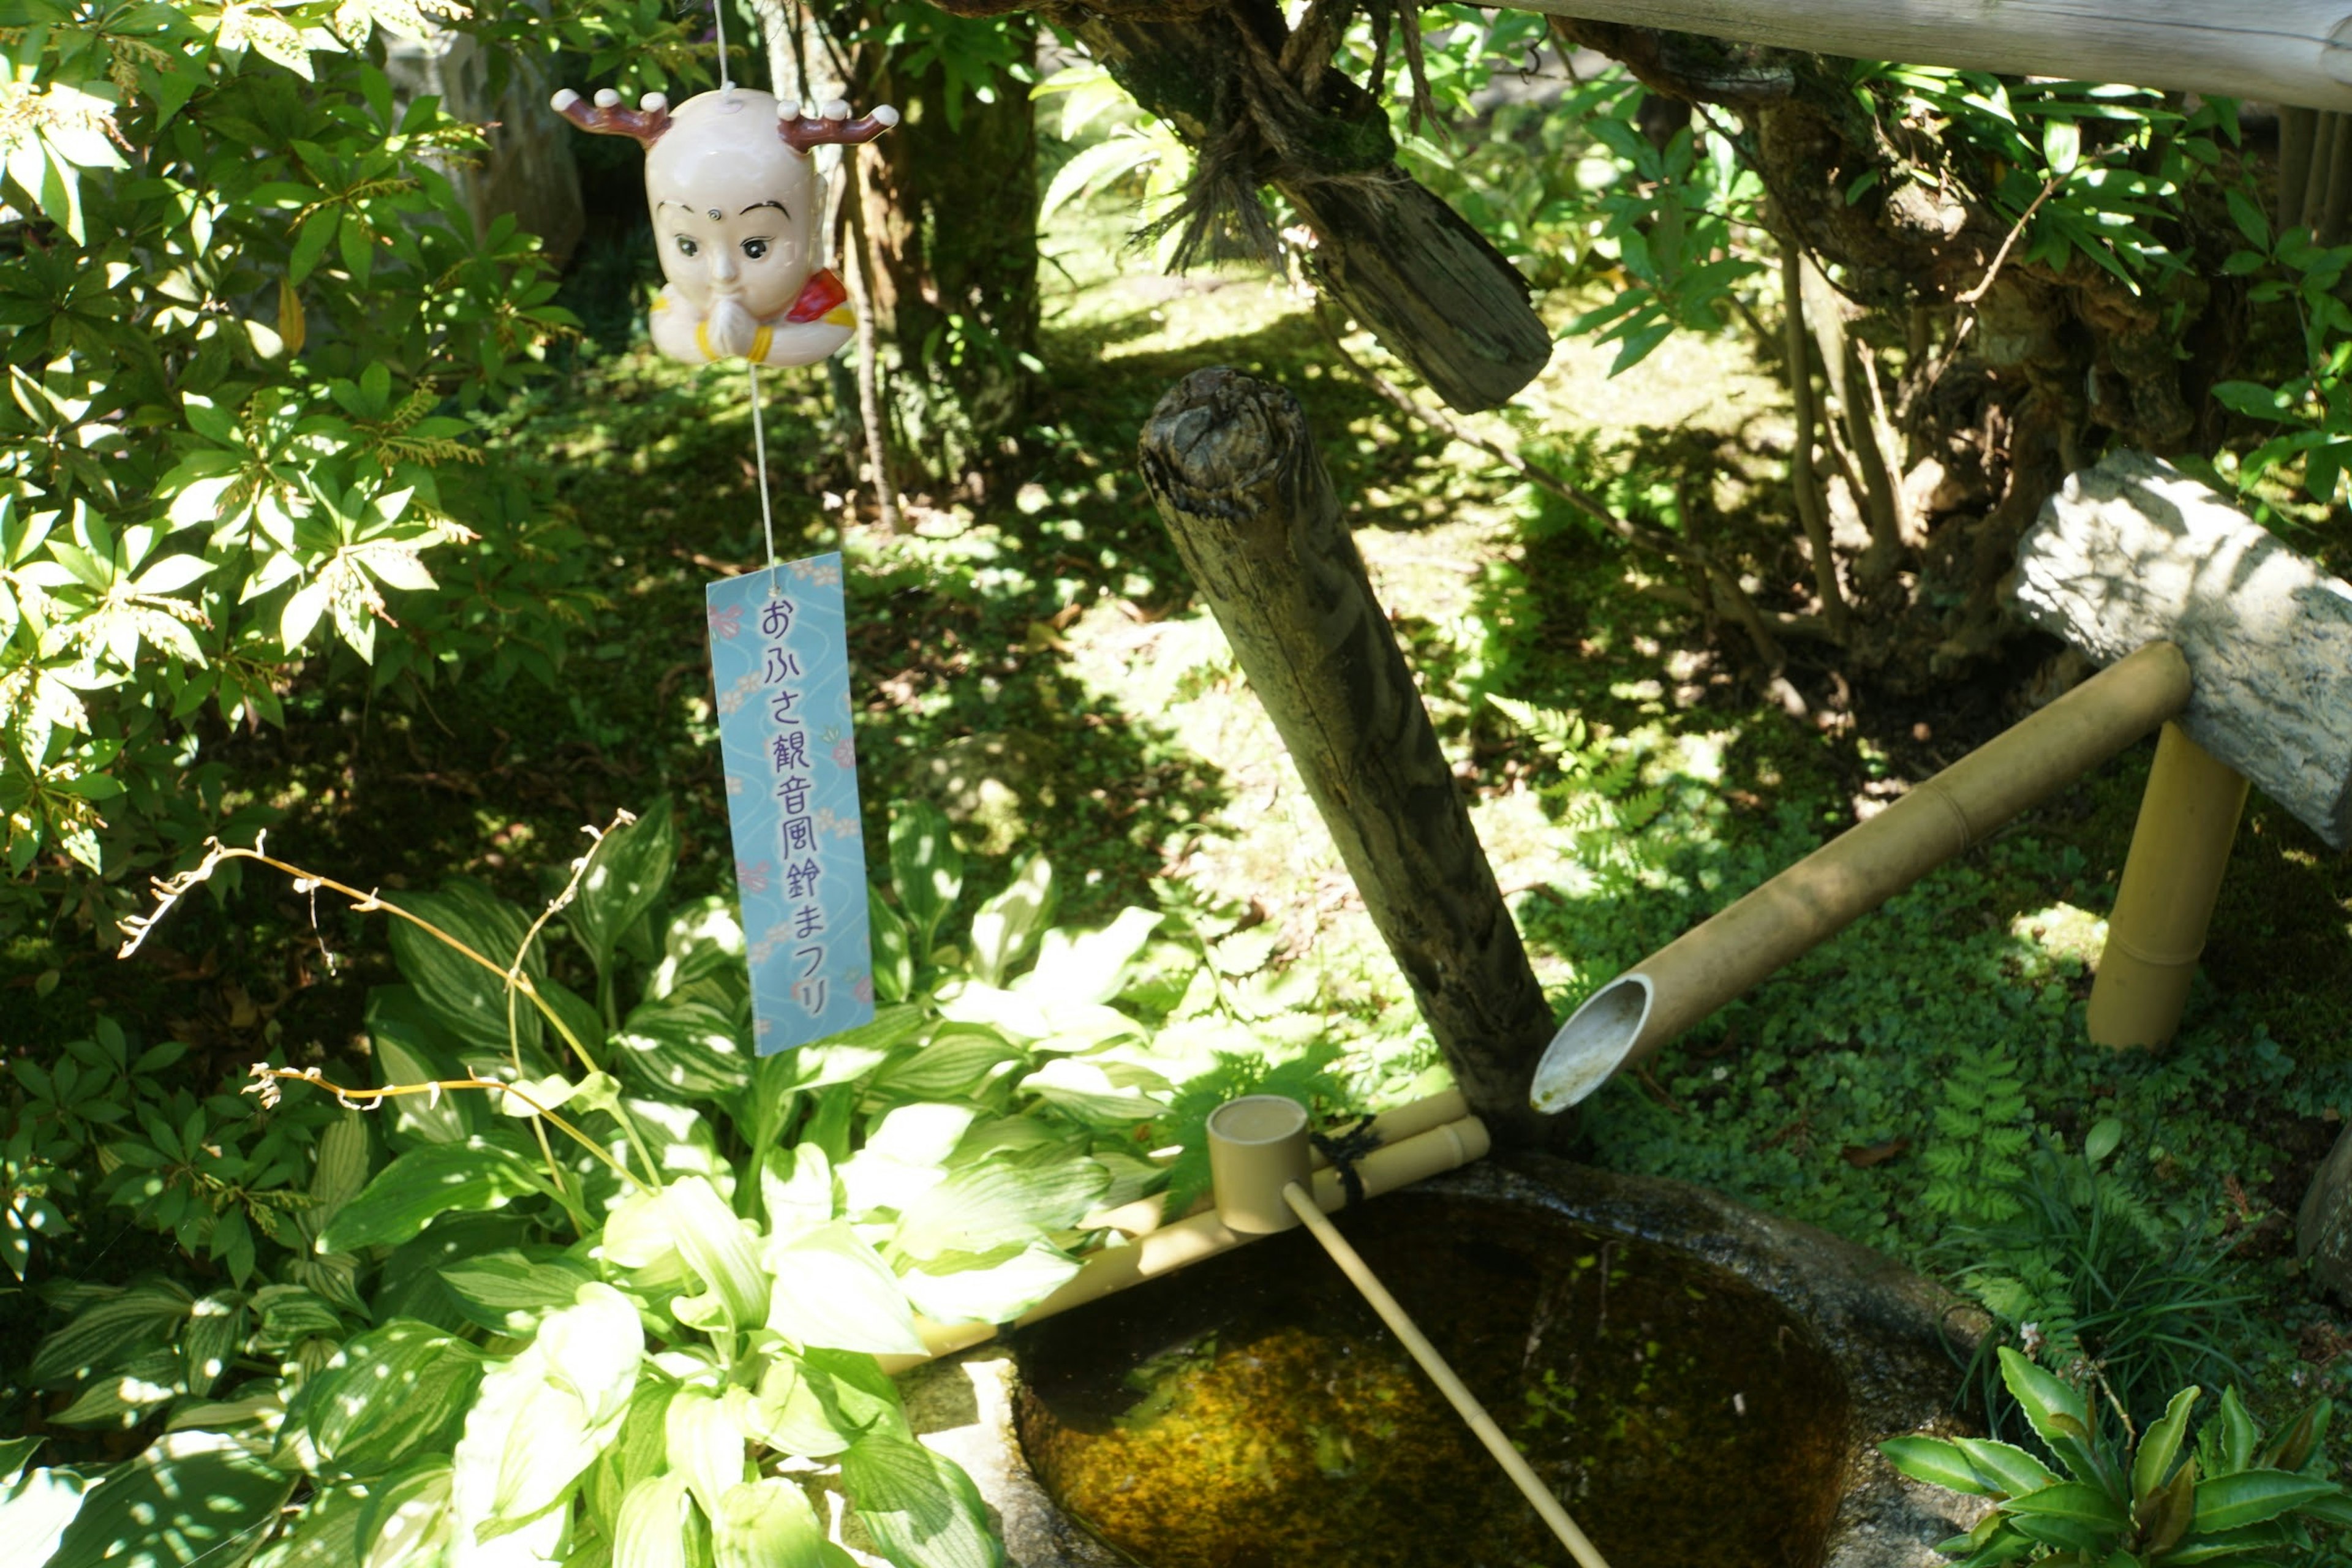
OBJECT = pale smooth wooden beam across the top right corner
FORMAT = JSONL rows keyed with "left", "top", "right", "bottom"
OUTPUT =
{"left": 1501, "top": 0, "right": 2352, "bottom": 108}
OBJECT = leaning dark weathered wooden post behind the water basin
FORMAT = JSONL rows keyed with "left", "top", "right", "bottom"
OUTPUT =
{"left": 1140, "top": 367, "right": 1552, "bottom": 1142}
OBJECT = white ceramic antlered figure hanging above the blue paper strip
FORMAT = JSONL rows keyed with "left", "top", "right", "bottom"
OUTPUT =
{"left": 555, "top": 87, "right": 899, "bottom": 364}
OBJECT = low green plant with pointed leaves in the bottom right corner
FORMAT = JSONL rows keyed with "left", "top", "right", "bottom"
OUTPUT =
{"left": 1879, "top": 1347, "right": 2352, "bottom": 1568}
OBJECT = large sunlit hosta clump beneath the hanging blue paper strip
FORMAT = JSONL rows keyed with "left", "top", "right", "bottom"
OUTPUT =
{"left": 0, "top": 806, "right": 1194, "bottom": 1568}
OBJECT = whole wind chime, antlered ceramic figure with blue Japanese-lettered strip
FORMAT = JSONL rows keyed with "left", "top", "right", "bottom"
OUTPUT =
{"left": 555, "top": 34, "right": 899, "bottom": 1055}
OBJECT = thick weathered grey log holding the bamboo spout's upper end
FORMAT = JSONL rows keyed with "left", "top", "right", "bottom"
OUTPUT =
{"left": 2011, "top": 451, "right": 2352, "bottom": 849}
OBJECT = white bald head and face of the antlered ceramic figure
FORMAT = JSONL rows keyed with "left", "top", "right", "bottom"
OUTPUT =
{"left": 644, "top": 87, "right": 818, "bottom": 320}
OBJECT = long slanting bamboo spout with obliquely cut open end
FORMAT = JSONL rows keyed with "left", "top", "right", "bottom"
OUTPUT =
{"left": 1529, "top": 642, "right": 2190, "bottom": 1112}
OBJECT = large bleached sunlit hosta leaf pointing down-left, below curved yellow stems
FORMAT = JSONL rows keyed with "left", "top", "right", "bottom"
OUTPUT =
{"left": 449, "top": 1284, "right": 644, "bottom": 1542}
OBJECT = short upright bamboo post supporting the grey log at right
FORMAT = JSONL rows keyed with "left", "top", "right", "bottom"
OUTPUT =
{"left": 2086, "top": 724, "right": 2246, "bottom": 1046}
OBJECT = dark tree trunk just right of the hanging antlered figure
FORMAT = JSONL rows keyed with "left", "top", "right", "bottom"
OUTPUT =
{"left": 851, "top": 17, "right": 1037, "bottom": 494}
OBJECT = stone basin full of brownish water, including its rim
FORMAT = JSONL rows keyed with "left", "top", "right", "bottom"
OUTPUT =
{"left": 905, "top": 1156, "right": 1973, "bottom": 1568}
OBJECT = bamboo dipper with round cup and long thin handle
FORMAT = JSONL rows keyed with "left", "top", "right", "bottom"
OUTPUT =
{"left": 1209, "top": 1096, "right": 1609, "bottom": 1568}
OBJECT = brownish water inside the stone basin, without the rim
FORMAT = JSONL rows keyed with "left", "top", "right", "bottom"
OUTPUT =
{"left": 1019, "top": 1192, "right": 1849, "bottom": 1568}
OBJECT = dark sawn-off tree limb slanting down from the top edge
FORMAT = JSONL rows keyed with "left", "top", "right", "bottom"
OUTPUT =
{"left": 1049, "top": 5, "right": 1552, "bottom": 414}
